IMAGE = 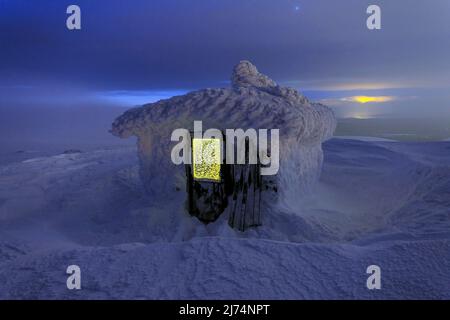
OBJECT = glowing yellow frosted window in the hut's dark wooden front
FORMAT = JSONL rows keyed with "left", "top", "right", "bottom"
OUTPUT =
{"left": 192, "top": 139, "right": 221, "bottom": 181}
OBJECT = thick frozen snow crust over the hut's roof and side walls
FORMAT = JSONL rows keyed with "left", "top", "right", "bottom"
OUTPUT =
{"left": 111, "top": 61, "right": 336, "bottom": 208}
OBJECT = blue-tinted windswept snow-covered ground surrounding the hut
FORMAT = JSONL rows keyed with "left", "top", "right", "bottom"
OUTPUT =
{"left": 0, "top": 139, "right": 450, "bottom": 299}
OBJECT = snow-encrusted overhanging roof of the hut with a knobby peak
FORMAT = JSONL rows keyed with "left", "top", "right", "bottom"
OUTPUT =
{"left": 111, "top": 61, "right": 336, "bottom": 143}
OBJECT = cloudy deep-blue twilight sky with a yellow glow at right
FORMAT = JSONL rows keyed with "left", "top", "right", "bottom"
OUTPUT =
{"left": 0, "top": 0, "right": 450, "bottom": 118}
